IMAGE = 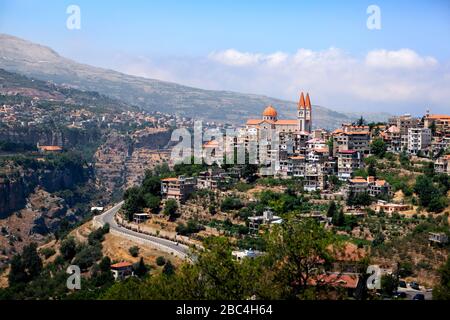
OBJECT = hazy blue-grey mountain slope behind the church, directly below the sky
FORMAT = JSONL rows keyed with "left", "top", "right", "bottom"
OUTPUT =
{"left": 0, "top": 34, "right": 386, "bottom": 128}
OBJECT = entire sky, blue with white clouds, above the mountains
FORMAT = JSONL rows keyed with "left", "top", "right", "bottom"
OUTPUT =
{"left": 0, "top": 0, "right": 450, "bottom": 115}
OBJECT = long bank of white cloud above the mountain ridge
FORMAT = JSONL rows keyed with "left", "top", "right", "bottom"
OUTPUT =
{"left": 110, "top": 48, "right": 450, "bottom": 114}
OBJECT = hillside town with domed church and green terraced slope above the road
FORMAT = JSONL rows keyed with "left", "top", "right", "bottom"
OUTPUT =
{"left": 94, "top": 93, "right": 450, "bottom": 300}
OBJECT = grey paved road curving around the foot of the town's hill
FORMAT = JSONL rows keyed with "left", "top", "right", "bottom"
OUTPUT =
{"left": 94, "top": 201, "right": 189, "bottom": 259}
